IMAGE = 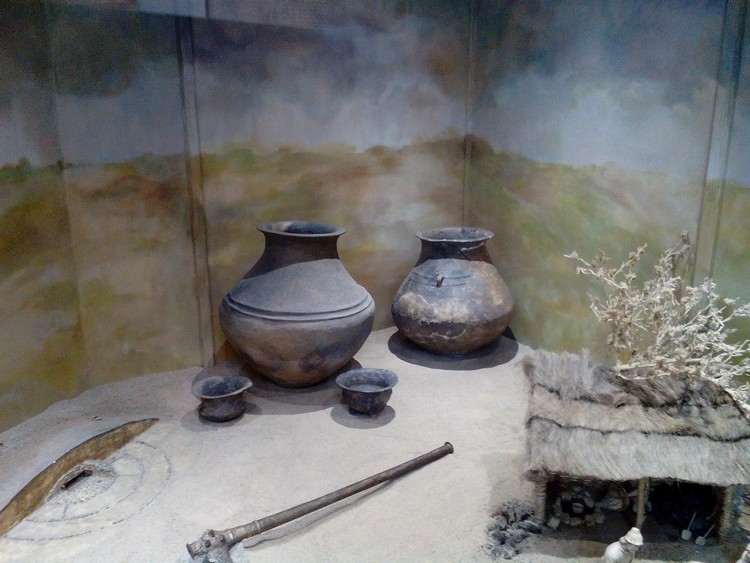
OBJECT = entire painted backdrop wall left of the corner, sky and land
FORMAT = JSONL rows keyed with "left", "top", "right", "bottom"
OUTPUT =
{"left": 0, "top": 0, "right": 471, "bottom": 427}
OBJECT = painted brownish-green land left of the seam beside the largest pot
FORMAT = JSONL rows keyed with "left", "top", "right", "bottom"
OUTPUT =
{"left": 0, "top": 157, "right": 200, "bottom": 427}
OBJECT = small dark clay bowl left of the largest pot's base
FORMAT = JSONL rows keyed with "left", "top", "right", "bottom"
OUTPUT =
{"left": 193, "top": 375, "right": 253, "bottom": 422}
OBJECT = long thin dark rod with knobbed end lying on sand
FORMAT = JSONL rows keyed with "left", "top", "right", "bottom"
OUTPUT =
{"left": 187, "top": 442, "right": 453, "bottom": 563}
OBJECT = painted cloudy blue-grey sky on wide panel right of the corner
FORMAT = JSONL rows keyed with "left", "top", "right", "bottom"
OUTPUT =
{"left": 473, "top": 0, "right": 736, "bottom": 178}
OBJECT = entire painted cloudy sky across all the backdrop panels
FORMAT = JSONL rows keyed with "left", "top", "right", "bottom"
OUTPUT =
{"left": 0, "top": 0, "right": 750, "bottom": 183}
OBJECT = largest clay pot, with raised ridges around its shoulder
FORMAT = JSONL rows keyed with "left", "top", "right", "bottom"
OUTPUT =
{"left": 219, "top": 221, "right": 375, "bottom": 387}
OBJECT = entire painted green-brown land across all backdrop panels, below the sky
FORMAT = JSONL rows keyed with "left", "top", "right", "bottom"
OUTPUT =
{"left": 0, "top": 135, "right": 750, "bottom": 426}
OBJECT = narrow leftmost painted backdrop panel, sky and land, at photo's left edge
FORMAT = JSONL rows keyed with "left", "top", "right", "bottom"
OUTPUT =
{"left": 0, "top": 2, "right": 87, "bottom": 429}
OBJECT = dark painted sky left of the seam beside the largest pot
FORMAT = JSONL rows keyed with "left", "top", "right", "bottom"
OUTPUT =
{"left": 0, "top": 5, "right": 184, "bottom": 164}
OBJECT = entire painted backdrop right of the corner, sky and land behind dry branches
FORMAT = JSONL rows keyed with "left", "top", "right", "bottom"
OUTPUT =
{"left": 468, "top": 0, "right": 750, "bottom": 358}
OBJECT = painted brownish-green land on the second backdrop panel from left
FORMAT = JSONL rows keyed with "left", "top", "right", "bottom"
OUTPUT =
{"left": 63, "top": 155, "right": 200, "bottom": 385}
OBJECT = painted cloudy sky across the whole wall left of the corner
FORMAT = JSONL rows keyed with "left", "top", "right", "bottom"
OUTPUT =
{"left": 0, "top": 2, "right": 469, "bottom": 163}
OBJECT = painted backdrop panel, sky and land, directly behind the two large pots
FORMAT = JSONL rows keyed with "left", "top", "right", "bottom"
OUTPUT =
{"left": 193, "top": 2, "right": 470, "bottom": 348}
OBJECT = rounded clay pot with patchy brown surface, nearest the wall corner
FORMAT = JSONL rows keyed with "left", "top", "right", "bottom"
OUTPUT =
{"left": 391, "top": 227, "right": 513, "bottom": 355}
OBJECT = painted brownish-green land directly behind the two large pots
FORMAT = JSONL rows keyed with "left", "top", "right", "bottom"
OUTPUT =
{"left": 202, "top": 137, "right": 464, "bottom": 346}
